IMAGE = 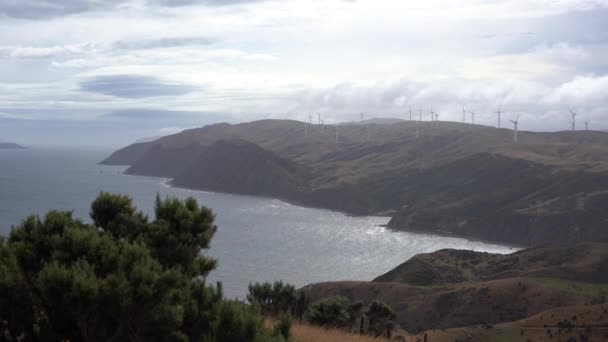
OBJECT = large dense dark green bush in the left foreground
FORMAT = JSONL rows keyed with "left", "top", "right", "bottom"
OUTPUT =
{"left": 0, "top": 193, "right": 288, "bottom": 342}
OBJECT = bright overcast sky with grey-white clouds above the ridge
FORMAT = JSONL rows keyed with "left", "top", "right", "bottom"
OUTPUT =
{"left": 0, "top": 0, "right": 608, "bottom": 146}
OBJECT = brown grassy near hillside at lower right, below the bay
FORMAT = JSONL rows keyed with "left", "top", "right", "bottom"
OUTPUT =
{"left": 300, "top": 243, "right": 608, "bottom": 341}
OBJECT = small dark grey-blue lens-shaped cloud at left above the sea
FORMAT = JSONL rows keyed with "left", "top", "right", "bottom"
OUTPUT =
{"left": 80, "top": 75, "right": 196, "bottom": 99}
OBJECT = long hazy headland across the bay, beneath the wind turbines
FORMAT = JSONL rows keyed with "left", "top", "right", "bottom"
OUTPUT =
{"left": 102, "top": 120, "right": 608, "bottom": 245}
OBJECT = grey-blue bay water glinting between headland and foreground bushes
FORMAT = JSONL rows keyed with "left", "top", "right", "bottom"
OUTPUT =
{"left": 0, "top": 148, "right": 513, "bottom": 298}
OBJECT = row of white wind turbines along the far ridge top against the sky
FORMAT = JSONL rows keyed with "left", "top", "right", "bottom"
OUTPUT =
{"left": 304, "top": 105, "right": 589, "bottom": 144}
